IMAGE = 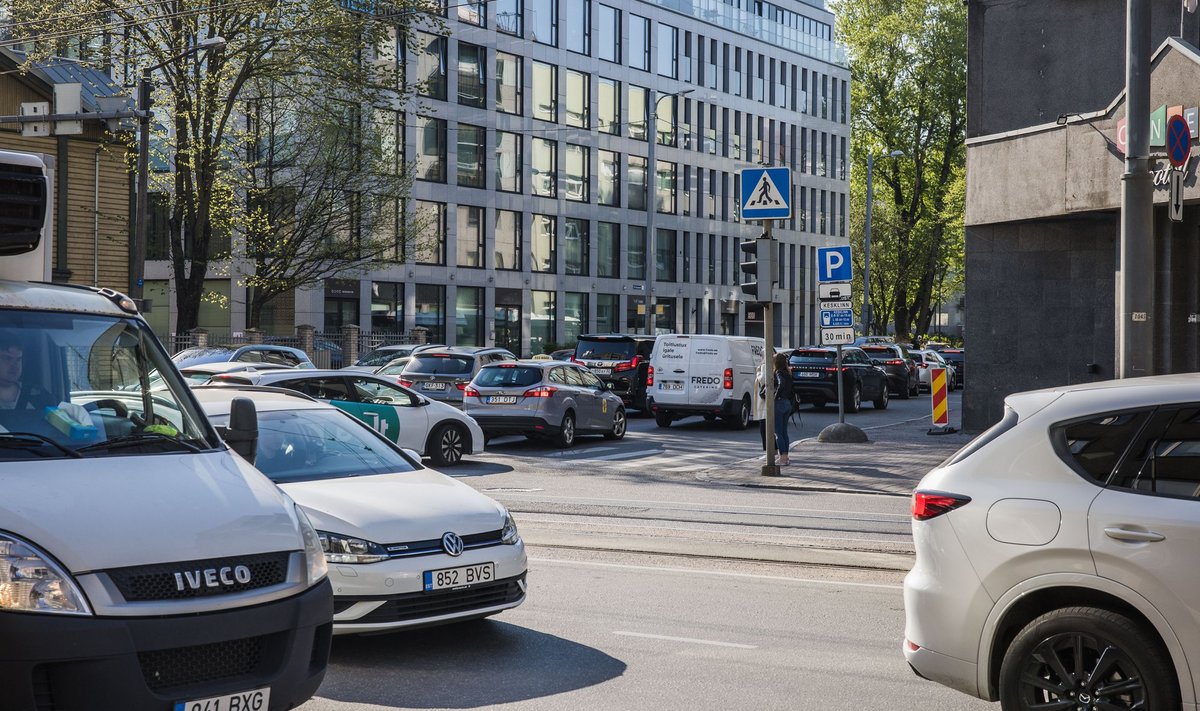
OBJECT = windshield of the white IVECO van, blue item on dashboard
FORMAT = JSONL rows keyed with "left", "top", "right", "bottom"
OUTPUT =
{"left": 0, "top": 309, "right": 217, "bottom": 460}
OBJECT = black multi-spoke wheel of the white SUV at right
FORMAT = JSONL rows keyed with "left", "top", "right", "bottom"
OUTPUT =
{"left": 1000, "top": 608, "right": 1181, "bottom": 711}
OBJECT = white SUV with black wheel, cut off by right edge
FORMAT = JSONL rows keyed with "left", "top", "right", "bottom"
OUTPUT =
{"left": 905, "top": 375, "right": 1200, "bottom": 711}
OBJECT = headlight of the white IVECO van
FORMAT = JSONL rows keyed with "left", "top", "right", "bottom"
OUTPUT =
{"left": 0, "top": 533, "right": 91, "bottom": 615}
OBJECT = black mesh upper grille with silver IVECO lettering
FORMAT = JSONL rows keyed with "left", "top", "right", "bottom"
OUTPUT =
{"left": 107, "top": 551, "right": 290, "bottom": 603}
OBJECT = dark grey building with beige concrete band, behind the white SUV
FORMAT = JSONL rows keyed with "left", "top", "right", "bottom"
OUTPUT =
{"left": 962, "top": 0, "right": 1200, "bottom": 431}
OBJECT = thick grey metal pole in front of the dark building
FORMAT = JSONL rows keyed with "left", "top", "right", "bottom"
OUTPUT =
{"left": 1117, "top": 0, "right": 1154, "bottom": 378}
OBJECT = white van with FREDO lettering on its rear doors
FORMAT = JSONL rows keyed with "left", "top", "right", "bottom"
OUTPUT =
{"left": 646, "top": 334, "right": 766, "bottom": 430}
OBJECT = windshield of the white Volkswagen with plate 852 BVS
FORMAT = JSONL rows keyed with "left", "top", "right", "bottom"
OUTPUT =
{"left": 212, "top": 407, "right": 416, "bottom": 484}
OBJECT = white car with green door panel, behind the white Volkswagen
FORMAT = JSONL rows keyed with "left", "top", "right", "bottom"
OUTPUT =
{"left": 209, "top": 370, "right": 484, "bottom": 466}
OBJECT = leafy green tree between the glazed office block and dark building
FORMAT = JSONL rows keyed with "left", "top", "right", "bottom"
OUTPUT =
{"left": 834, "top": 0, "right": 966, "bottom": 340}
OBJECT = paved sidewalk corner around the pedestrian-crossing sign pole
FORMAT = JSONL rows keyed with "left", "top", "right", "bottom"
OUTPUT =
{"left": 697, "top": 417, "right": 972, "bottom": 496}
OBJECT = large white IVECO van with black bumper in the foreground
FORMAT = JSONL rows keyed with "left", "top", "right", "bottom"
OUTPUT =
{"left": 0, "top": 151, "right": 332, "bottom": 711}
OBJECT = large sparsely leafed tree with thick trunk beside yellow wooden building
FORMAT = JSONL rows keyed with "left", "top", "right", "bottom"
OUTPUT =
{"left": 11, "top": 0, "right": 430, "bottom": 331}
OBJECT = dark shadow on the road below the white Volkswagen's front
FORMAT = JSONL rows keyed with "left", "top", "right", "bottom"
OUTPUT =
{"left": 317, "top": 620, "right": 625, "bottom": 709}
